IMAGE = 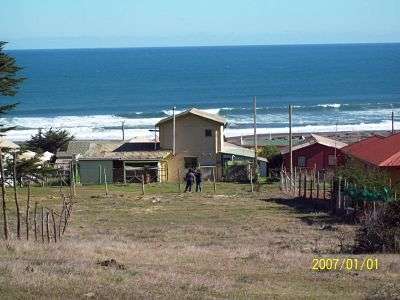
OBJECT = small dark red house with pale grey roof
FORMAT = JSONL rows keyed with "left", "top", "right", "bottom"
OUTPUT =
{"left": 282, "top": 134, "right": 346, "bottom": 171}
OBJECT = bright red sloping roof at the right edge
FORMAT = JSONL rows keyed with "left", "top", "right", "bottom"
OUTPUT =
{"left": 343, "top": 133, "right": 400, "bottom": 167}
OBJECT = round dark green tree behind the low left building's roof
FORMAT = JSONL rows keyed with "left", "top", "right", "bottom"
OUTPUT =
{"left": 26, "top": 128, "right": 74, "bottom": 153}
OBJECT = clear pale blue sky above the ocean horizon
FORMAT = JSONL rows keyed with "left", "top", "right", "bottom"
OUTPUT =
{"left": 0, "top": 0, "right": 400, "bottom": 49}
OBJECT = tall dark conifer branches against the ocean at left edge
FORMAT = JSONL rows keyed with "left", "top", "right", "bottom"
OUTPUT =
{"left": 0, "top": 41, "right": 25, "bottom": 133}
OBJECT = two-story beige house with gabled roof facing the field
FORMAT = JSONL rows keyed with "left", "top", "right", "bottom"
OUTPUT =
{"left": 156, "top": 108, "right": 266, "bottom": 181}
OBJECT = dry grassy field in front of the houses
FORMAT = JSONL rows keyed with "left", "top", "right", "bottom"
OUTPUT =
{"left": 0, "top": 184, "right": 400, "bottom": 299}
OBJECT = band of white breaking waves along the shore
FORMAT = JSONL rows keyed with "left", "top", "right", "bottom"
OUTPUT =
{"left": 0, "top": 103, "right": 400, "bottom": 141}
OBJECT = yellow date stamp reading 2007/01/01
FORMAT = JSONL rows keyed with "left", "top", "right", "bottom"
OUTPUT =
{"left": 311, "top": 257, "right": 380, "bottom": 272}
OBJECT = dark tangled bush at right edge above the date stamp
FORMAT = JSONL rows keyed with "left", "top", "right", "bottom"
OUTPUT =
{"left": 355, "top": 201, "right": 400, "bottom": 253}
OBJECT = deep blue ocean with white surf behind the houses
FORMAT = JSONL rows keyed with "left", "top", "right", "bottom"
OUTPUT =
{"left": 0, "top": 44, "right": 400, "bottom": 140}
